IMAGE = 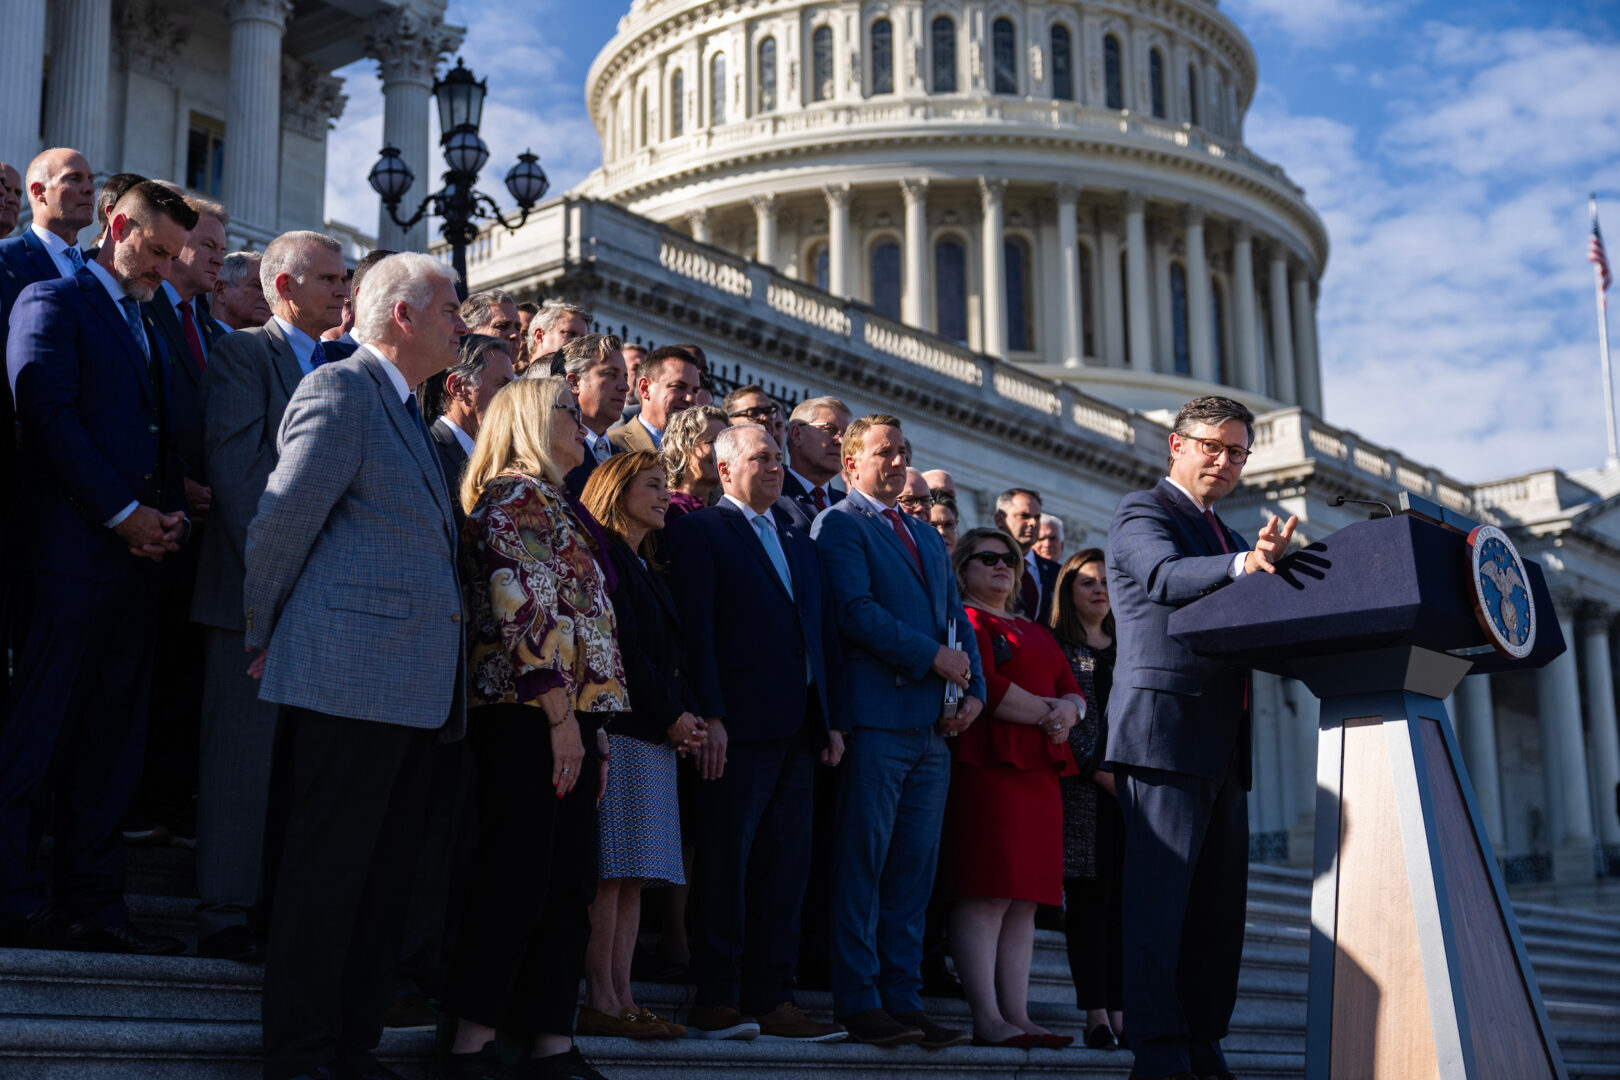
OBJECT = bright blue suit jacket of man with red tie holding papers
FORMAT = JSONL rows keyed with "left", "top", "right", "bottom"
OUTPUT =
{"left": 810, "top": 499, "right": 985, "bottom": 730}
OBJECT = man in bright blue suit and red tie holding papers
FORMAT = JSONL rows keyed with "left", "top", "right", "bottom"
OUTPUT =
{"left": 812, "top": 415, "right": 985, "bottom": 1048}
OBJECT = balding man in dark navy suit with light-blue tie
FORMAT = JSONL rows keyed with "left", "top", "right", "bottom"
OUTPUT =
{"left": 667, "top": 424, "right": 847, "bottom": 1043}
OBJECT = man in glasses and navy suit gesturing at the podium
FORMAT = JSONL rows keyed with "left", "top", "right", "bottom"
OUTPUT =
{"left": 1106, "top": 397, "right": 1296, "bottom": 1080}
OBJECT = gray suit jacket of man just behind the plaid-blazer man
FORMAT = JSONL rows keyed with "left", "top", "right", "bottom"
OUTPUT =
{"left": 191, "top": 319, "right": 303, "bottom": 631}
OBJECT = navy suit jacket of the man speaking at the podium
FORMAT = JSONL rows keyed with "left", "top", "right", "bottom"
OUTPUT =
{"left": 1106, "top": 479, "right": 1252, "bottom": 789}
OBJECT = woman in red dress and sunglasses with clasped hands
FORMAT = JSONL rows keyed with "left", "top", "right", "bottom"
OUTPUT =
{"left": 946, "top": 528, "right": 1085, "bottom": 1049}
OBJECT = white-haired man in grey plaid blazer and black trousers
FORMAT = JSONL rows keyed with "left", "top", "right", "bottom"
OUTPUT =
{"left": 245, "top": 254, "right": 467, "bottom": 1080}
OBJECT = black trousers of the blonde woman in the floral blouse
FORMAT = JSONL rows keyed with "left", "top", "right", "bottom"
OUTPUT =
{"left": 449, "top": 704, "right": 599, "bottom": 1038}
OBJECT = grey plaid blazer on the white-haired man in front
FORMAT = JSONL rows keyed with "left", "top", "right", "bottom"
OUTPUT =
{"left": 243, "top": 348, "right": 467, "bottom": 738}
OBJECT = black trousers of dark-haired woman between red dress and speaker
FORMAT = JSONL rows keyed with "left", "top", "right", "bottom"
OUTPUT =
{"left": 1063, "top": 792, "right": 1124, "bottom": 1012}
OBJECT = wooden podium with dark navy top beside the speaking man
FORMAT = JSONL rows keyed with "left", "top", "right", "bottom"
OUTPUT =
{"left": 1170, "top": 495, "right": 1567, "bottom": 1080}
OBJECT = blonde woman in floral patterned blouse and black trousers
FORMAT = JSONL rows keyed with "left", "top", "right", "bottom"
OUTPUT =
{"left": 434, "top": 376, "right": 630, "bottom": 1080}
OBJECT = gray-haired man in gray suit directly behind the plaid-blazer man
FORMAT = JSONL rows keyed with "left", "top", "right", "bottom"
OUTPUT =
{"left": 191, "top": 232, "right": 347, "bottom": 960}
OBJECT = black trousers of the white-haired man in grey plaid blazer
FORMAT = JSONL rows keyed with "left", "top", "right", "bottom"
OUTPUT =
{"left": 262, "top": 708, "right": 437, "bottom": 1080}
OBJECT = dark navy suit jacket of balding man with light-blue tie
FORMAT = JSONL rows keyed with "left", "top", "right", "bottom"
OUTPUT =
{"left": 663, "top": 499, "right": 847, "bottom": 742}
